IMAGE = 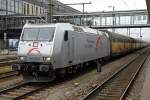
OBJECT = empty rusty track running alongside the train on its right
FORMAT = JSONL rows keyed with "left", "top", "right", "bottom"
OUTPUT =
{"left": 83, "top": 48, "right": 149, "bottom": 100}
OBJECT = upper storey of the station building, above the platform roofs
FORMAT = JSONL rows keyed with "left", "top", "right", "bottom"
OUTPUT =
{"left": 0, "top": 0, "right": 80, "bottom": 15}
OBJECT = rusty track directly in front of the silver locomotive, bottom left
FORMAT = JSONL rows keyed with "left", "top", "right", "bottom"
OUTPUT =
{"left": 0, "top": 82, "right": 48, "bottom": 100}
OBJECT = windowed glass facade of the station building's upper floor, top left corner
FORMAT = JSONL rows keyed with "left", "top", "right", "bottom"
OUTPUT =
{"left": 0, "top": 0, "right": 45, "bottom": 15}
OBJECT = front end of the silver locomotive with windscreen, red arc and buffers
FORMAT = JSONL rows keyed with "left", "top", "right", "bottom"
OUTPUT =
{"left": 12, "top": 26, "right": 55, "bottom": 82}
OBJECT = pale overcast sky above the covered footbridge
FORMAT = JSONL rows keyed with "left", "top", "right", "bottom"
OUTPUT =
{"left": 58, "top": 0, "right": 146, "bottom": 12}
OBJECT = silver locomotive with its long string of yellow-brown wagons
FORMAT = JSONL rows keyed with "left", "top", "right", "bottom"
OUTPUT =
{"left": 12, "top": 23, "right": 147, "bottom": 82}
